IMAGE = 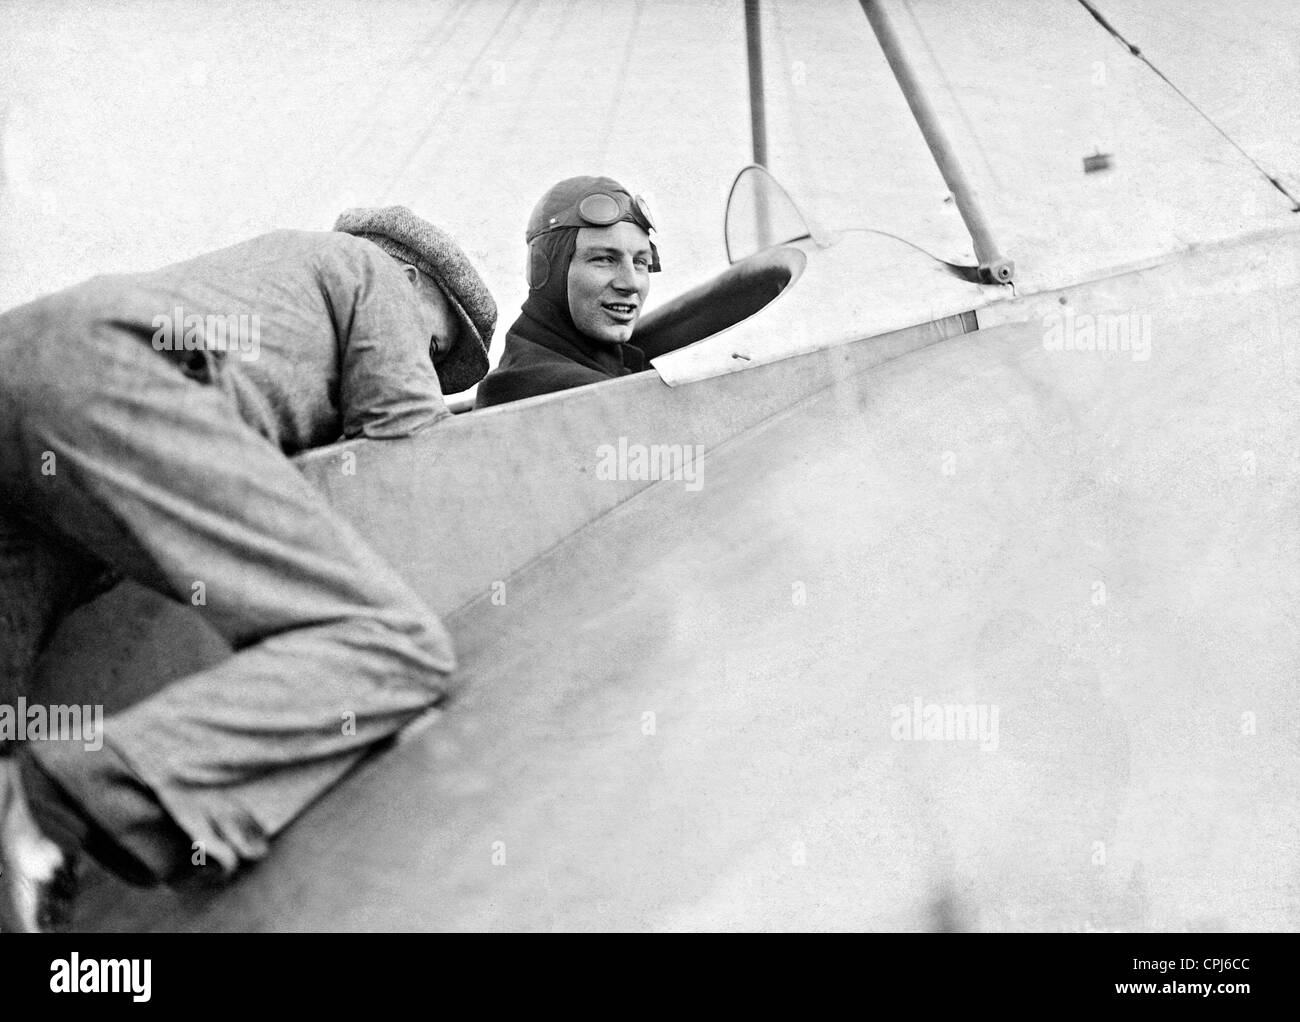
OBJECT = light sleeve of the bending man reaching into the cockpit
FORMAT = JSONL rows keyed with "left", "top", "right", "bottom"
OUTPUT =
{"left": 321, "top": 235, "right": 451, "bottom": 439}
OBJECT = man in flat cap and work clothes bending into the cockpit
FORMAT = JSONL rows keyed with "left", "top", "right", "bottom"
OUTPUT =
{"left": 0, "top": 207, "right": 497, "bottom": 931}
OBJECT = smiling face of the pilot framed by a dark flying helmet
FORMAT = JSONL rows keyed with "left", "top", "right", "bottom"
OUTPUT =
{"left": 568, "top": 221, "right": 650, "bottom": 345}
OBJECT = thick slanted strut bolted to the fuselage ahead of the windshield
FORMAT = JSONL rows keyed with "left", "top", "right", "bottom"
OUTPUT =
{"left": 859, "top": 0, "right": 1015, "bottom": 283}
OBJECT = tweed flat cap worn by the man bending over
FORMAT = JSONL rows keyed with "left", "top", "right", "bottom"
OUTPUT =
{"left": 334, "top": 205, "right": 497, "bottom": 394}
